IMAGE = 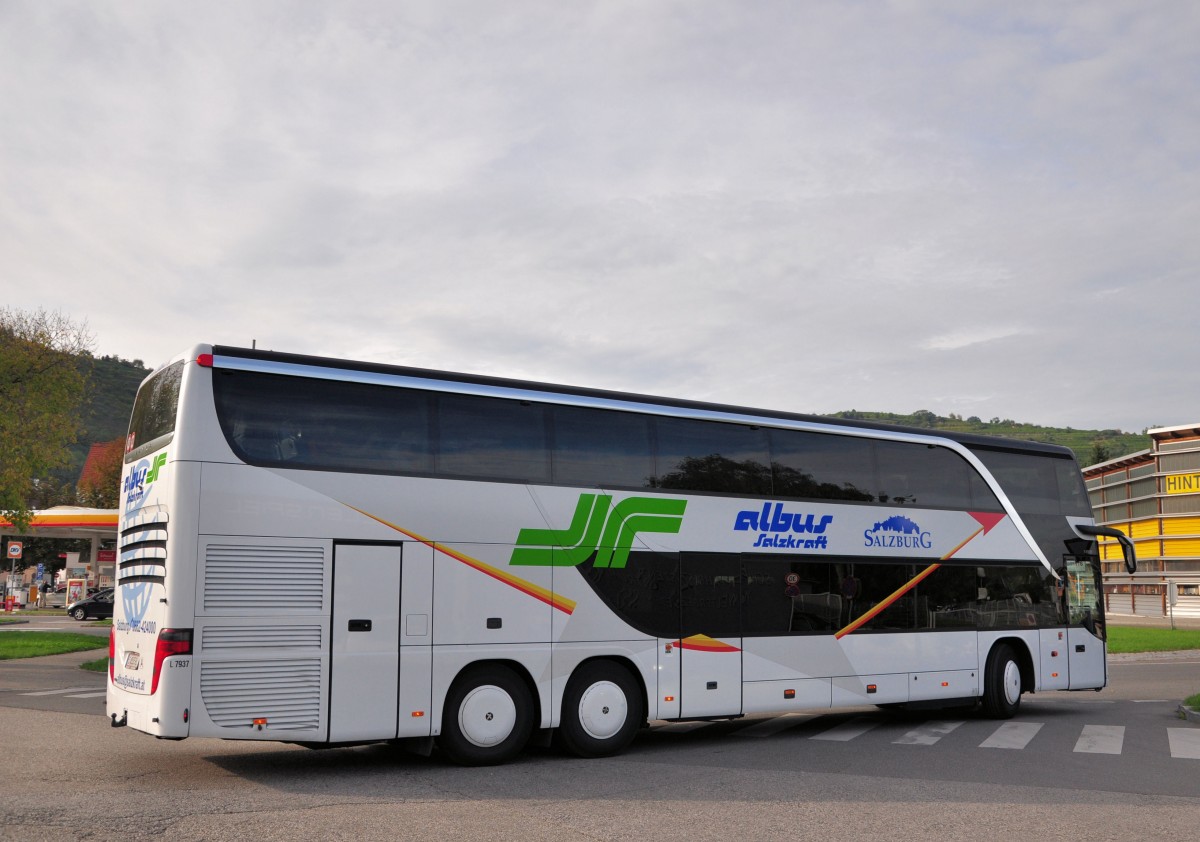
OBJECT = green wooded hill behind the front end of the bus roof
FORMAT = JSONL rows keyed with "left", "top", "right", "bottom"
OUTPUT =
{"left": 829, "top": 409, "right": 1150, "bottom": 468}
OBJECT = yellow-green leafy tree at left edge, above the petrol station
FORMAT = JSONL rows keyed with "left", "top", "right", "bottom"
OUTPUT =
{"left": 0, "top": 307, "right": 92, "bottom": 531}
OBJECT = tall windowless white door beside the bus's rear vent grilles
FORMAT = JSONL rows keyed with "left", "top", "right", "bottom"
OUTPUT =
{"left": 329, "top": 543, "right": 401, "bottom": 742}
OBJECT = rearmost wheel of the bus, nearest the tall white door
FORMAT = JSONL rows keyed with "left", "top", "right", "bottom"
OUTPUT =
{"left": 438, "top": 664, "right": 534, "bottom": 766}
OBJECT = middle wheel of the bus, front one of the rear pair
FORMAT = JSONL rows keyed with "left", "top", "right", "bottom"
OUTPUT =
{"left": 558, "top": 661, "right": 646, "bottom": 757}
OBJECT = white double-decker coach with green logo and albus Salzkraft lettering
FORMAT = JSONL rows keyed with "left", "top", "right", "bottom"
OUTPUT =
{"left": 107, "top": 345, "right": 1134, "bottom": 764}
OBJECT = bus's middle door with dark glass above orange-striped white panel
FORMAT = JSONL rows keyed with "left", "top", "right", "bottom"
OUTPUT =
{"left": 679, "top": 553, "right": 742, "bottom": 718}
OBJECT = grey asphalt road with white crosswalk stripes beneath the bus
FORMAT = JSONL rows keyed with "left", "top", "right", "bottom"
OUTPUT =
{"left": 0, "top": 618, "right": 1200, "bottom": 842}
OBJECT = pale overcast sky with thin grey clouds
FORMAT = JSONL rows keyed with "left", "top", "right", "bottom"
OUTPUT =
{"left": 0, "top": 0, "right": 1200, "bottom": 432}
